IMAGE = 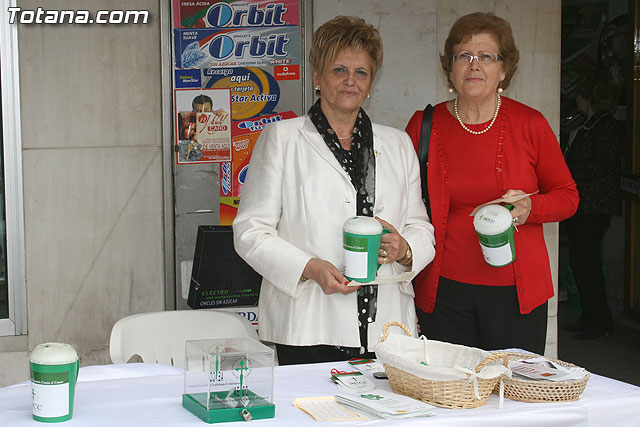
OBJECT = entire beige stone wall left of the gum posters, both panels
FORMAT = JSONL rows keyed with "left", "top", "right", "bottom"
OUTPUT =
{"left": 0, "top": 0, "right": 171, "bottom": 376}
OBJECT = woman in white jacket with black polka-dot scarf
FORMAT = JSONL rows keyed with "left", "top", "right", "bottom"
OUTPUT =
{"left": 233, "top": 16, "right": 435, "bottom": 364}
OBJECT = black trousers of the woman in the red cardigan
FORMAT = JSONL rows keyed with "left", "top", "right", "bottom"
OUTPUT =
{"left": 416, "top": 277, "right": 547, "bottom": 354}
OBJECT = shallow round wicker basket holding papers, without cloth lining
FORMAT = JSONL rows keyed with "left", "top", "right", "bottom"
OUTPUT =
{"left": 493, "top": 352, "right": 590, "bottom": 402}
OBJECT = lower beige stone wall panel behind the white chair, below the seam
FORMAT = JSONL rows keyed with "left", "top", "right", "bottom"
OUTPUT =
{"left": 24, "top": 148, "right": 164, "bottom": 349}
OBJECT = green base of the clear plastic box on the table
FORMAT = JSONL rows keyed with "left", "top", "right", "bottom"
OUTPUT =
{"left": 182, "top": 391, "right": 276, "bottom": 424}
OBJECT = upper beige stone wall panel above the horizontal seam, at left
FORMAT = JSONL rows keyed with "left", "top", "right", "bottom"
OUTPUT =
{"left": 18, "top": 0, "right": 162, "bottom": 149}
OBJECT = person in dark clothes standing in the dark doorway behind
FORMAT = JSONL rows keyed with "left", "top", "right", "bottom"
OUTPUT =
{"left": 564, "top": 70, "right": 624, "bottom": 339}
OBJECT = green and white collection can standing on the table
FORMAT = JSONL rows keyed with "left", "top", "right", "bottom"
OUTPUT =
{"left": 30, "top": 343, "right": 80, "bottom": 423}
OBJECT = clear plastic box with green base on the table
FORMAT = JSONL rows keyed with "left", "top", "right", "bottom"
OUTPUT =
{"left": 182, "top": 338, "right": 275, "bottom": 423}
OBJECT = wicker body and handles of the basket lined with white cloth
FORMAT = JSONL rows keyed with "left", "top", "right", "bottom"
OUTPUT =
{"left": 381, "top": 322, "right": 509, "bottom": 409}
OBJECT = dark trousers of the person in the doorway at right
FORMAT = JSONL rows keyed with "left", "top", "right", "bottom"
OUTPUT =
{"left": 566, "top": 214, "right": 613, "bottom": 329}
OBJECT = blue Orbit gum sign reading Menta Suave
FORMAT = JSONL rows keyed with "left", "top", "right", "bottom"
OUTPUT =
{"left": 174, "top": 26, "right": 300, "bottom": 69}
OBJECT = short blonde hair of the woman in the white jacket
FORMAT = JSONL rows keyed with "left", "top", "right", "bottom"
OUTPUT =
{"left": 309, "top": 16, "right": 382, "bottom": 80}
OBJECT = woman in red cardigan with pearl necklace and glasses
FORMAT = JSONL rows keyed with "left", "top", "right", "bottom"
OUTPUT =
{"left": 406, "top": 13, "right": 579, "bottom": 354}
